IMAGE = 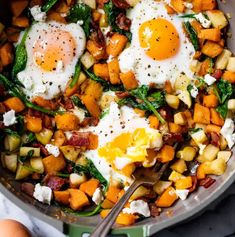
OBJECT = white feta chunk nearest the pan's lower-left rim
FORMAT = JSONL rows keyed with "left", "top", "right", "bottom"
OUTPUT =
{"left": 33, "top": 183, "right": 52, "bottom": 205}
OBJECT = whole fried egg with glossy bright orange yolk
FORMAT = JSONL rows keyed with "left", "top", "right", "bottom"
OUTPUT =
{"left": 119, "top": 0, "right": 195, "bottom": 86}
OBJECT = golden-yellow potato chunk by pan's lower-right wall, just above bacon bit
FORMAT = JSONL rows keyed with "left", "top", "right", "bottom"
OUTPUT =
{"left": 204, "top": 159, "right": 227, "bottom": 175}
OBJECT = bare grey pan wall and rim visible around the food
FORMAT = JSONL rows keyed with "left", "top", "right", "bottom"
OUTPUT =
{"left": 0, "top": 0, "right": 235, "bottom": 237}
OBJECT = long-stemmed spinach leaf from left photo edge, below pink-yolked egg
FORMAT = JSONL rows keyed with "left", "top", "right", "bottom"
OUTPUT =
{"left": 0, "top": 74, "right": 58, "bottom": 116}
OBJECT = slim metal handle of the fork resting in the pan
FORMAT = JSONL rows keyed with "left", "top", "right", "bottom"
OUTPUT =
{"left": 90, "top": 180, "right": 143, "bottom": 237}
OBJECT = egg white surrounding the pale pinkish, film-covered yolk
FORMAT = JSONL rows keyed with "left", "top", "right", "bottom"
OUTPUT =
{"left": 17, "top": 21, "right": 86, "bottom": 99}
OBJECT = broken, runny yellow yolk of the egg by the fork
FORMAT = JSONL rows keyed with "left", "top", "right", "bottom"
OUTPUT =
{"left": 98, "top": 128, "right": 162, "bottom": 166}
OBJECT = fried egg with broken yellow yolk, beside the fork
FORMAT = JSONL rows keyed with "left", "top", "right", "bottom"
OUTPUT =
{"left": 81, "top": 102, "right": 162, "bottom": 182}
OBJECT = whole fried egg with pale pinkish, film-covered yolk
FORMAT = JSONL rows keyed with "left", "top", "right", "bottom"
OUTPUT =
{"left": 17, "top": 21, "right": 86, "bottom": 99}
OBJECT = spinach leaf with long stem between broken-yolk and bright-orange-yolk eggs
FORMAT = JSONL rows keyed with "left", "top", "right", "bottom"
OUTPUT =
{"left": 130, "top": 85, "right": 166, "bottom": 123}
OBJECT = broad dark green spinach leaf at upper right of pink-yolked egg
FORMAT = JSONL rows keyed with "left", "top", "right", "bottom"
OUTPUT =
{"left": 67, "top": 3, "right": 91, "bottom": 37}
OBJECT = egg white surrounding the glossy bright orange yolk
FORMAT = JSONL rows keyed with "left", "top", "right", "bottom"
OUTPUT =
{"left": 119, "top": 0, "right": 195, "bottom": 86}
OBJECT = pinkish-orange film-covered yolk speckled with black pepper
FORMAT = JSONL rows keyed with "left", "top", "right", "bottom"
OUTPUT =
{"left": 33, "top": 29, "right": 76, "bottom": 71}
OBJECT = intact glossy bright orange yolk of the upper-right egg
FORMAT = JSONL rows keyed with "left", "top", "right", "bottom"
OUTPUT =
{"left": 139, "top": 18, "right": 180, "bottom": 60}
